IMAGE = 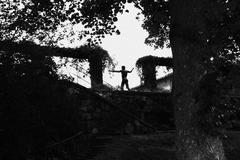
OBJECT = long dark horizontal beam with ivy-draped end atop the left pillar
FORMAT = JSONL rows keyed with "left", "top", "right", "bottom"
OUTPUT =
{"left": 0, "top": 41, "right": 115, "bottom": 82}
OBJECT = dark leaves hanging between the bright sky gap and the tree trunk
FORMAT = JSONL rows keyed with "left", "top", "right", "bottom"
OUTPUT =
{"left": 140, "top": 0, "right": 170, "bottom": 48}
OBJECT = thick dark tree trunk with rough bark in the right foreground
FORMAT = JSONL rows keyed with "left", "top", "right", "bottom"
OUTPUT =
{"left": 170, "top": 0, "right": 225, "bottom": 160}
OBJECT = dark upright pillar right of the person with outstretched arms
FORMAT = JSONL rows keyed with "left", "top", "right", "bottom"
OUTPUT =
{"left": 142, "top": 64, "right": 157, "bottom": 90}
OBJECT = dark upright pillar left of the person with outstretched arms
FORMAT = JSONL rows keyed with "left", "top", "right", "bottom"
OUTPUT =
{"left": 88, "top": 55, "right": 103, "bottom": 88}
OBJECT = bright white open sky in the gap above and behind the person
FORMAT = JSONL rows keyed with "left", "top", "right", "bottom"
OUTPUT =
{"left": 60, "top": 4, "right": 171, "bottom": 88}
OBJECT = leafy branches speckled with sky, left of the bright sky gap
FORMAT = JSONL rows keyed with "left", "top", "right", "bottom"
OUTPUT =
{"left": 0, "top": 0, "right": 126, "bottom": 43}
